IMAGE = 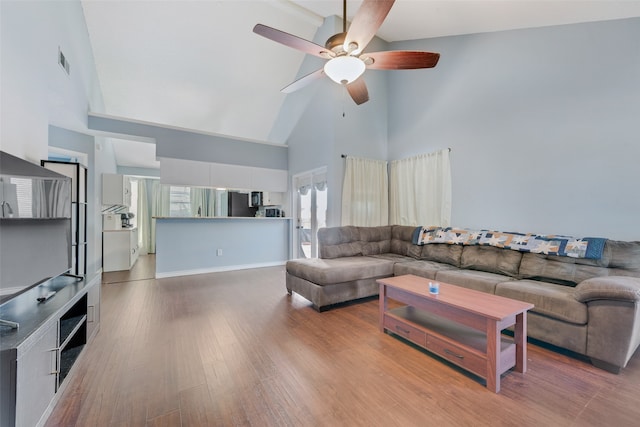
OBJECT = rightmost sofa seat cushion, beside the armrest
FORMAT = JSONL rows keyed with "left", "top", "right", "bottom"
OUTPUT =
{"left": 496, "top": 280, "right": 588, "bottom": 325}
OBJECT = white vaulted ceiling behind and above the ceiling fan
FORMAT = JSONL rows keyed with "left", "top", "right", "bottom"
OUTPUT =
{"left": 82, "top": 0, "right": 640, "bottom": 166}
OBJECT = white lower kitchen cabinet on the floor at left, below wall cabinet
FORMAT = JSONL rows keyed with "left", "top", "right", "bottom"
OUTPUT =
{"left": 102, "top": 228, "right": 138, "bottom": 272}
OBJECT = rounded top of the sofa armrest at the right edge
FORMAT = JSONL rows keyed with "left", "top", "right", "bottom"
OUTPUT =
{"left": 574, "top": 276, "right": 640, "bottom": 303}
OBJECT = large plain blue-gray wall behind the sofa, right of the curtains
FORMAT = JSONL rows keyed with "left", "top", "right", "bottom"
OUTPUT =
{"left": 389, "top": 18, "right": 640, "bottom": 240}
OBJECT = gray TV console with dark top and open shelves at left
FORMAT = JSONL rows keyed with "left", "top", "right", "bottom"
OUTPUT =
{"left": 0, "top": 275, "right": 101, "bottom": 427}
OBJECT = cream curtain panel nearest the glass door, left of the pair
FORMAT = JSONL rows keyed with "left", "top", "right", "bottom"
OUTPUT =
{"left": 342, "top": 157, "right": 389, "bottom": 226}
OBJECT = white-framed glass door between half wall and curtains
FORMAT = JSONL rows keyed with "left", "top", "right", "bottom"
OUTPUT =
{"left": 292, "top": 167, "right": 328, "bottom": 258}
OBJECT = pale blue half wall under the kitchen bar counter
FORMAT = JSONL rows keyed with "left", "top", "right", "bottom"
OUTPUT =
{"left": 154, "top": 217, "right": 292, "bottom": 278}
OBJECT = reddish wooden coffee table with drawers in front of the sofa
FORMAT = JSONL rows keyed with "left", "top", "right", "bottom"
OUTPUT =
{"left": 377, "top": 274, "right": 533, "bottom": 393}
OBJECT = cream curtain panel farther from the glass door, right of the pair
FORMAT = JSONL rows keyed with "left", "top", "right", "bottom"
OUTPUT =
{"left": 389, "top": 149, "right": 451, "bottom": 227}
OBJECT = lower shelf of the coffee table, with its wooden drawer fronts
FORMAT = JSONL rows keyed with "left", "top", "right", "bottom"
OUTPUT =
{"left": 383, "top": 306, "right": 516, "bottom": 391}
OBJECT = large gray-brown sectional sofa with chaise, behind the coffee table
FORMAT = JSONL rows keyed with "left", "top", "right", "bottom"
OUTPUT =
{"left": 286, "top": 225, "right": 640, "bottom": 373}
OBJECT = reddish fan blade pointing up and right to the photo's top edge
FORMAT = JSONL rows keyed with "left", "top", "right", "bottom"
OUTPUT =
{"left": 344, "top": 0, "right": 395, "bottom": 54}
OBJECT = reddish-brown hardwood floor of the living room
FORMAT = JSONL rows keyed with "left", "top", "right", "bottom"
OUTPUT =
{"left": 47, "top": 260, "right": 640, "bottom": 427}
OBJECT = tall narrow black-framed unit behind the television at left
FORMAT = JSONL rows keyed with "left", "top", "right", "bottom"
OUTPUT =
{"left": 40, "top": 160, "right": 87, "bottom": 277}
